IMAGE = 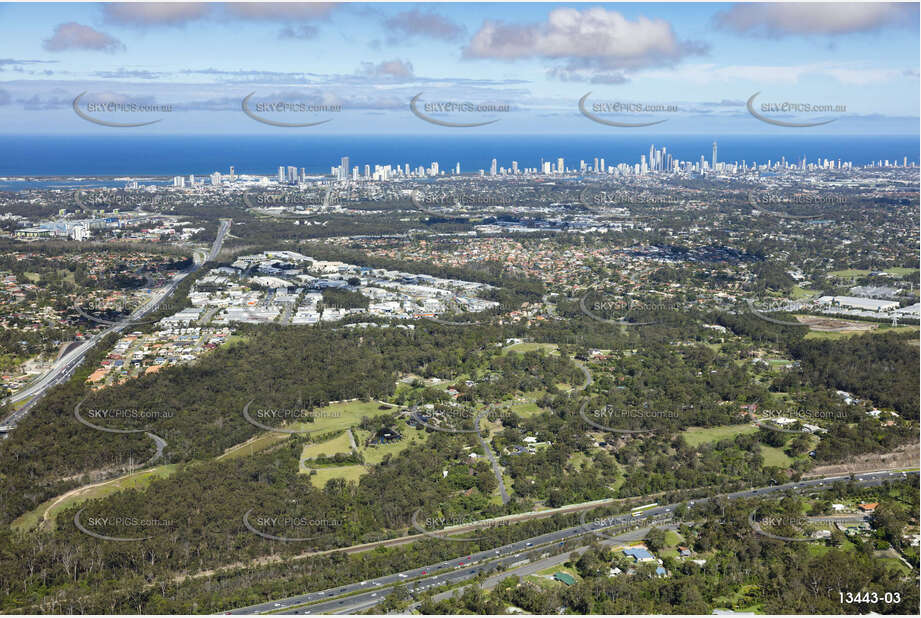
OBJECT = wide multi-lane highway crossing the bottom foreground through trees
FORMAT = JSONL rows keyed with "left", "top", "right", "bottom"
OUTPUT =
{"left": 227, "top": 470, "right": 918, "bottom": 614}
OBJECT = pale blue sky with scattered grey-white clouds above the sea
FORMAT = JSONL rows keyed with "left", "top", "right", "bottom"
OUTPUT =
{"left": 0, "top": 2, "right": 921, "bottom": 136}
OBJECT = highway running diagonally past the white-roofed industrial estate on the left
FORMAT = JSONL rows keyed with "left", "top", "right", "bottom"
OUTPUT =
{"left": 0, "top": 220, "right": 231, "bottom": 428}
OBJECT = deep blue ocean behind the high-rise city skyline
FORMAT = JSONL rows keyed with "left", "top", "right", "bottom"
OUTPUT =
{"left": 0, "top": 134, "right": 919, "bottom": 186}
